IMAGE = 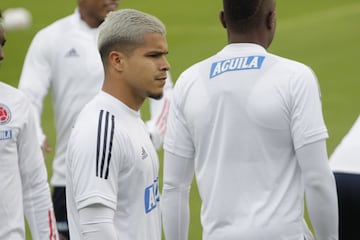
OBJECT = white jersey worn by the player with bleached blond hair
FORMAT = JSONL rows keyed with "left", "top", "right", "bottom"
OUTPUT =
{"left": 66, "top": 92, "right": 161, "bottom": 240}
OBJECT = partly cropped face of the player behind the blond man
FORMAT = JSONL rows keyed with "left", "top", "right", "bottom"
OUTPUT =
{"left": 79, "top": 0, "right": 120, "bottom": 27}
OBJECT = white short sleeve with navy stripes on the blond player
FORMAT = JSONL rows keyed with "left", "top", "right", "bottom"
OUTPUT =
{"left": 67, "top": 112, "right": 125, "bottom": 209}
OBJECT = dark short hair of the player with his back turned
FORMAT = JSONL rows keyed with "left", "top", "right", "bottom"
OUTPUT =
{"left": 223, "top": 0, "right": 267, "bottom": 32}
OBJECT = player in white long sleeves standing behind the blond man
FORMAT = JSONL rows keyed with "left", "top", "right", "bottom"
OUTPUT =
{"left": 19, "top": 0, "right": 172, "bottom": 239}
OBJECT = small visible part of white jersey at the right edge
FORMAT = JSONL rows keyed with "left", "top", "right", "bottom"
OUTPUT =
{"left": 330, "top": 115, "right": 360, "bottom": 174}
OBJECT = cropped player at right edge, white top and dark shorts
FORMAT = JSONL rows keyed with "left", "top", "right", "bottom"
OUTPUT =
{"left": 330, "top": 115, "right": 360, "bottom": 240}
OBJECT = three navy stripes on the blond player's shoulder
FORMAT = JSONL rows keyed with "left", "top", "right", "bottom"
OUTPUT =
{"left": 96, "top": 110, "right": 115, "bottom": 179}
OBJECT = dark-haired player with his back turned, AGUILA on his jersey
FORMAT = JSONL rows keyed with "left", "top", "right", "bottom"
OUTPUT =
{"left": 162, "top": 0, "right": 338, "bottom": 240}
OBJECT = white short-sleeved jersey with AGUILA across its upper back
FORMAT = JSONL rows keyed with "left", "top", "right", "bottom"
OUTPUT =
{"left": 164, "top": 43, "right": 328, "bottom": 240}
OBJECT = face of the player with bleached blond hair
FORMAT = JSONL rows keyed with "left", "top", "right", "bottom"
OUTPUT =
{"left": 124, "top": 33, "right": 170, "bottom": 99}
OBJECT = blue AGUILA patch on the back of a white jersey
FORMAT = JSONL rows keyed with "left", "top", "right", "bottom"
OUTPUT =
{"left": 210, "top": 56, "right": 265, "bottom": 78}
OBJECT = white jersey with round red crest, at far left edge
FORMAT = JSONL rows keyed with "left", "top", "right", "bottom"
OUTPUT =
{"left": 0, "top": 82, "right": 57, "bottom": 240}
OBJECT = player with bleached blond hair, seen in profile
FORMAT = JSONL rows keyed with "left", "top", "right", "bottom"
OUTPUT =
{"left": 66, "top": 9, "right": 170, "bottom": 240}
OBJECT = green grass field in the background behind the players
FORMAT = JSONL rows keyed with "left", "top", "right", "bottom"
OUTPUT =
{"left": 0, "top": 0, "right": 360, "bottom": 240}
